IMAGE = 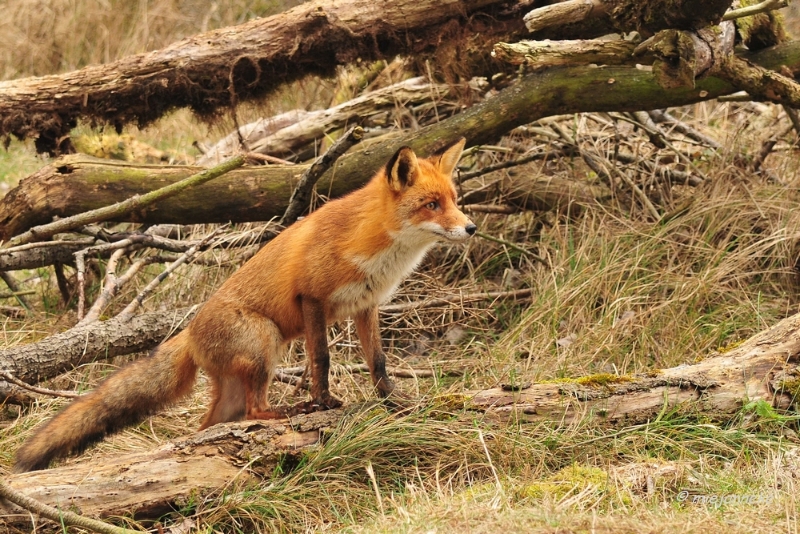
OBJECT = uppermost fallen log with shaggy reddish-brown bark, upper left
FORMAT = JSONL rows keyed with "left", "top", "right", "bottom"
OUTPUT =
{"left": 0, "top": 0, "right": 524, "bottom": 153}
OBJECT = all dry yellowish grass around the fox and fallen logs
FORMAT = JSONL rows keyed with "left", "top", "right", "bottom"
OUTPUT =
{"left": 0, "top": 0, "right": 800, "bottom": 534}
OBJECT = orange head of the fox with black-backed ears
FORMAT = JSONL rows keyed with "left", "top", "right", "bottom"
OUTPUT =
{"left": 386, "top": 138, "right": 478, "bottom": 242}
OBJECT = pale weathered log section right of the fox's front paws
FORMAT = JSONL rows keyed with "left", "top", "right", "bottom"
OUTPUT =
{"left": 468, "top": 314, "right": 800, "bottom": 425}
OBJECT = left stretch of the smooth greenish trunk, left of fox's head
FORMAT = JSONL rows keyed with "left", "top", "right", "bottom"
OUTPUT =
{"left": 0, "top": 154, "right": 316, "bottom": 240}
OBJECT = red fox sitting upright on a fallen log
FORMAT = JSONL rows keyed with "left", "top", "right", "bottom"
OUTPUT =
{"left": 14, "top": 139, "right": 477, "bottom": 472}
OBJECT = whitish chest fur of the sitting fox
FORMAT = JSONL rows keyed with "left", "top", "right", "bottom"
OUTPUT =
{"left": 331, "top": 225, "right": 435, "bottom": 319}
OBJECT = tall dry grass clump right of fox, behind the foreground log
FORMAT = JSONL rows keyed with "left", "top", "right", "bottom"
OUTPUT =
{"left": 497, "top": 184, "right": 800, "bottom": 382}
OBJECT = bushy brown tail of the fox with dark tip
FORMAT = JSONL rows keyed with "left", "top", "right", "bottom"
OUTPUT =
{"left": 14, "top": 330, "right": 197, "bottom": 473}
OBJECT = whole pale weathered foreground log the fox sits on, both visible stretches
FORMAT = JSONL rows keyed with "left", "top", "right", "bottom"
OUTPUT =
{"left": 0, "top": 314, "right": 800, "bottom": 525}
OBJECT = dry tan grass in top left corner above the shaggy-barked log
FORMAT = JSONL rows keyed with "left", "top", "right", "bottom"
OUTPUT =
{"left": 0, "top": 0, "right": 301, "bottom": 80}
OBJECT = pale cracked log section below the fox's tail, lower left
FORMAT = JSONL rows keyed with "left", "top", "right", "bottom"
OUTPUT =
{"left": 0, "top": 408, "right": 346, "bottom": 526}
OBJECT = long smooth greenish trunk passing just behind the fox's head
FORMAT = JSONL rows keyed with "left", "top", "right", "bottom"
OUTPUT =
{"left": 0, "top": 41, "right": 800, "bottom": 239}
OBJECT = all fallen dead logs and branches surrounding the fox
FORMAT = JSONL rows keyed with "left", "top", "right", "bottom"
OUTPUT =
{"left": 0, "top": 0, "right": 800, "bottom": 525}
